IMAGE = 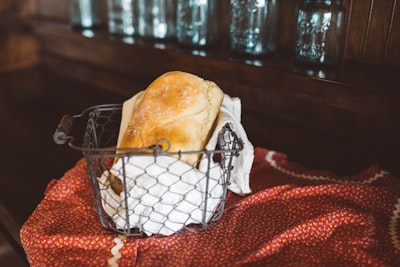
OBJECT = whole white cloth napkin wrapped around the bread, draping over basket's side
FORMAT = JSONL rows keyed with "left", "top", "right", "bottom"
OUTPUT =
{"left": 99, "top": 93, "right": 254, "bottom": 236}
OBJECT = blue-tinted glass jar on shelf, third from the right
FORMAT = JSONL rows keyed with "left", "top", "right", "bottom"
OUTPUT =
{"left": 176, "top": 0, "right": 218, "bottom": 46}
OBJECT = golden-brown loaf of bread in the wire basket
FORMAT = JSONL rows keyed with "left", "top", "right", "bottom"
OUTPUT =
{"left": 111, "top": 71, "right": 224, "bottom": 193}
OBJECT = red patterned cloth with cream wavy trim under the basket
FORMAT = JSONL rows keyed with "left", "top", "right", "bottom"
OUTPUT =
{"left": 21, "top": 148, "right": 400, "bottom": 267}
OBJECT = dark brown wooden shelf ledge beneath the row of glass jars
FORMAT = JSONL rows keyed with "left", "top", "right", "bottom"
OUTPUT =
{"left": 37, "top": 24, "right": 400, "bottom": 113}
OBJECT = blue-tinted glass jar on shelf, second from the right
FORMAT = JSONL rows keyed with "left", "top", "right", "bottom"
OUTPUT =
{"left": 230, "top": 0, "right": 278, "bottom": 55}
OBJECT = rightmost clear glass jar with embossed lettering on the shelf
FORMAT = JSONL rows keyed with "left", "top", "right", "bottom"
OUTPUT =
{"left": 295, "top": 0, "right": 345, "bottom": 65}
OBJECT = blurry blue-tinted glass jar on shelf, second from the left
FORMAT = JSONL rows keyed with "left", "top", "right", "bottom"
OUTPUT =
{"left": 107, "top": 0, "right": 135, "bottom": 35}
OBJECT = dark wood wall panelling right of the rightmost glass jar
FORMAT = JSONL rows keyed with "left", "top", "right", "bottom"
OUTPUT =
{"left": 343, "top": 0, "right": 400, "bottom": 65}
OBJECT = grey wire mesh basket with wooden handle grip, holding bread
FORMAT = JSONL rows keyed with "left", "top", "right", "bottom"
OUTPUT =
{"left": 54, "top": 104, "right": 243, "bottom": 236}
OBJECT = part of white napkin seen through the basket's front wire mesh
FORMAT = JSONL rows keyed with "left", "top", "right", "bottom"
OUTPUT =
{"left": 100, "top": 156, "right": 223, "bottom": 236}
